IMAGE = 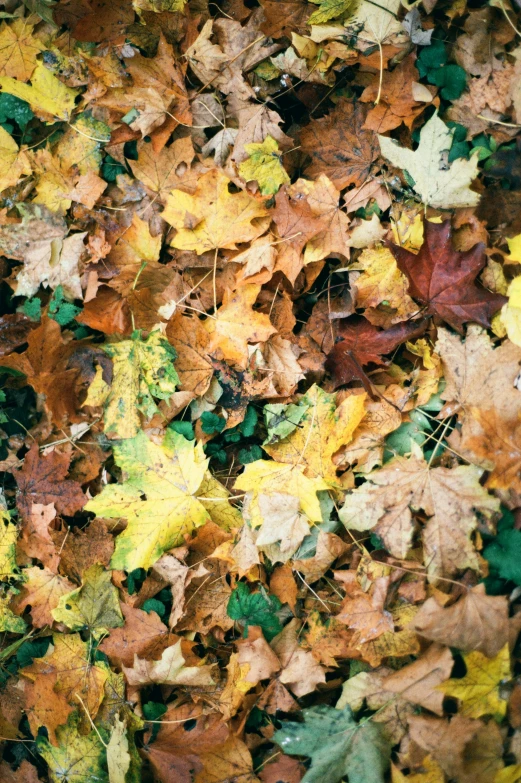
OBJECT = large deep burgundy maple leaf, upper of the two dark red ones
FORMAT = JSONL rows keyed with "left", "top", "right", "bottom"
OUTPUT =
{"left": 389, "top": 220, "right": 507, "bottom": 332}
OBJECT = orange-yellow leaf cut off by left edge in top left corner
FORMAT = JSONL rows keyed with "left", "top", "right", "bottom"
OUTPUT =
{"left": 0, "top": 17, "right": 45, "bottom": 82}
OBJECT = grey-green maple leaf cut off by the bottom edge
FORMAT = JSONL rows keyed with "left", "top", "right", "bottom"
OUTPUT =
{"left": 273, "top": 704, "right": 391, "bottom": 783}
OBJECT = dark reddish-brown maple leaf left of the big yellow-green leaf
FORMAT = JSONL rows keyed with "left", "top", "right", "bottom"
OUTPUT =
{"left": 13, "top": 443, "right": 87, "bottom": 521}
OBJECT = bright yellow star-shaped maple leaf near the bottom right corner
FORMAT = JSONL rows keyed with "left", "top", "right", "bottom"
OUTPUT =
{"left": 437, "top": 644, "right": 511, "bottom": 720}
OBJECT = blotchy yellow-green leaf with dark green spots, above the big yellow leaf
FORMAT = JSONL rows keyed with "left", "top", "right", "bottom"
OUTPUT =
{"left": 83, "top": 330, "right": 179, "bottom": 439}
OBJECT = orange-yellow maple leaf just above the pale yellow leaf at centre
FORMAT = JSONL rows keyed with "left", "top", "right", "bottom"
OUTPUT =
{"left": 264, "top": 384, "right": 366, "bottom": 486}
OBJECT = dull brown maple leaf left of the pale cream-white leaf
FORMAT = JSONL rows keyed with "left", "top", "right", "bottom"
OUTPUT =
{"left": 300, "top": 98, "right": 380, "bottom": 190}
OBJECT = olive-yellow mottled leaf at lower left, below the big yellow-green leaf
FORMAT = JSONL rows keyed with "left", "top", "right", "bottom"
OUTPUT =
{"left": 52, "top": 565, "right": 124, "bottom": 635}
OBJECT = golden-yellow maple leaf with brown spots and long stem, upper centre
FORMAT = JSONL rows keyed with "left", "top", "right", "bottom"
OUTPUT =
{"left": 162, "top": 169, "right": 269, "bottom": 255}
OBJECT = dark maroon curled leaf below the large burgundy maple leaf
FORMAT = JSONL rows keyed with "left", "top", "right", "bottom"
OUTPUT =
{"left": 326, "top": 316, "right": 427, "bottom": 392}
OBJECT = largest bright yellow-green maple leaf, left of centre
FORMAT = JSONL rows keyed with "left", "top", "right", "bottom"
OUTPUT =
{"left": 85, "top": 431, "right": 209, "bottom": 571}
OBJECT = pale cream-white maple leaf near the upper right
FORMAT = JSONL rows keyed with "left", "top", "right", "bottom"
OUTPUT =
{"left": 378, "top": 112, "right": 479, "bottom": 209}
